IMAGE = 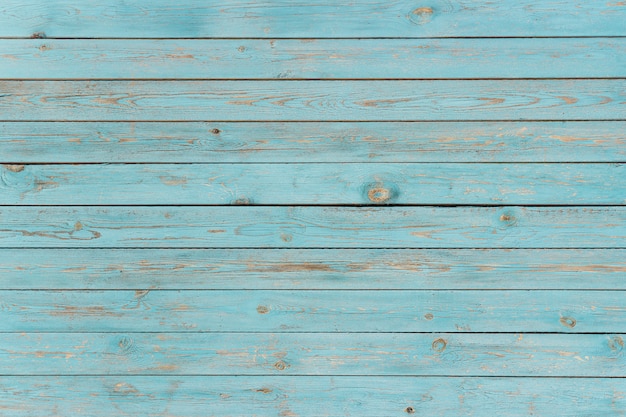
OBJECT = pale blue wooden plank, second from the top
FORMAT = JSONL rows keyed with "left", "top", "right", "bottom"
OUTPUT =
{"left": 0, "top": 38, "right": 626, "bottom": 79}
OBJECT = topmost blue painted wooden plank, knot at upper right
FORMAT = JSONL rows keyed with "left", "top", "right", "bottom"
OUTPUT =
{"left": 0, "top": 0, "right": 626, "bottom": 38}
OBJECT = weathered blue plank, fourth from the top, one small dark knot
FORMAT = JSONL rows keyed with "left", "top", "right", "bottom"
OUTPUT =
{"left": 0, "top": 122, "right": 626, "bottom": 164}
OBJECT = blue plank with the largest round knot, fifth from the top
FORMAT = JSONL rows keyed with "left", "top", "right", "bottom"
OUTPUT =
{"left": 0, "top": 163, "right": 626, "bottom": 205}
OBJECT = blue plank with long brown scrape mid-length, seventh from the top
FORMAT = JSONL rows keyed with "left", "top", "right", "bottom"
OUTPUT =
{"left": 0, "top": 249, "right": 626, "bottom": 290}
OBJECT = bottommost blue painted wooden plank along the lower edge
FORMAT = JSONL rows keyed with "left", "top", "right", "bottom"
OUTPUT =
{"left": 0, "top": 376, "right": 626, "bottom": 417}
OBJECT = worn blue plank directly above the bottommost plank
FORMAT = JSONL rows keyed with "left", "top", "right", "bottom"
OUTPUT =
{"left": 0, "top": 333, "right": 626, "bottom": 377}
